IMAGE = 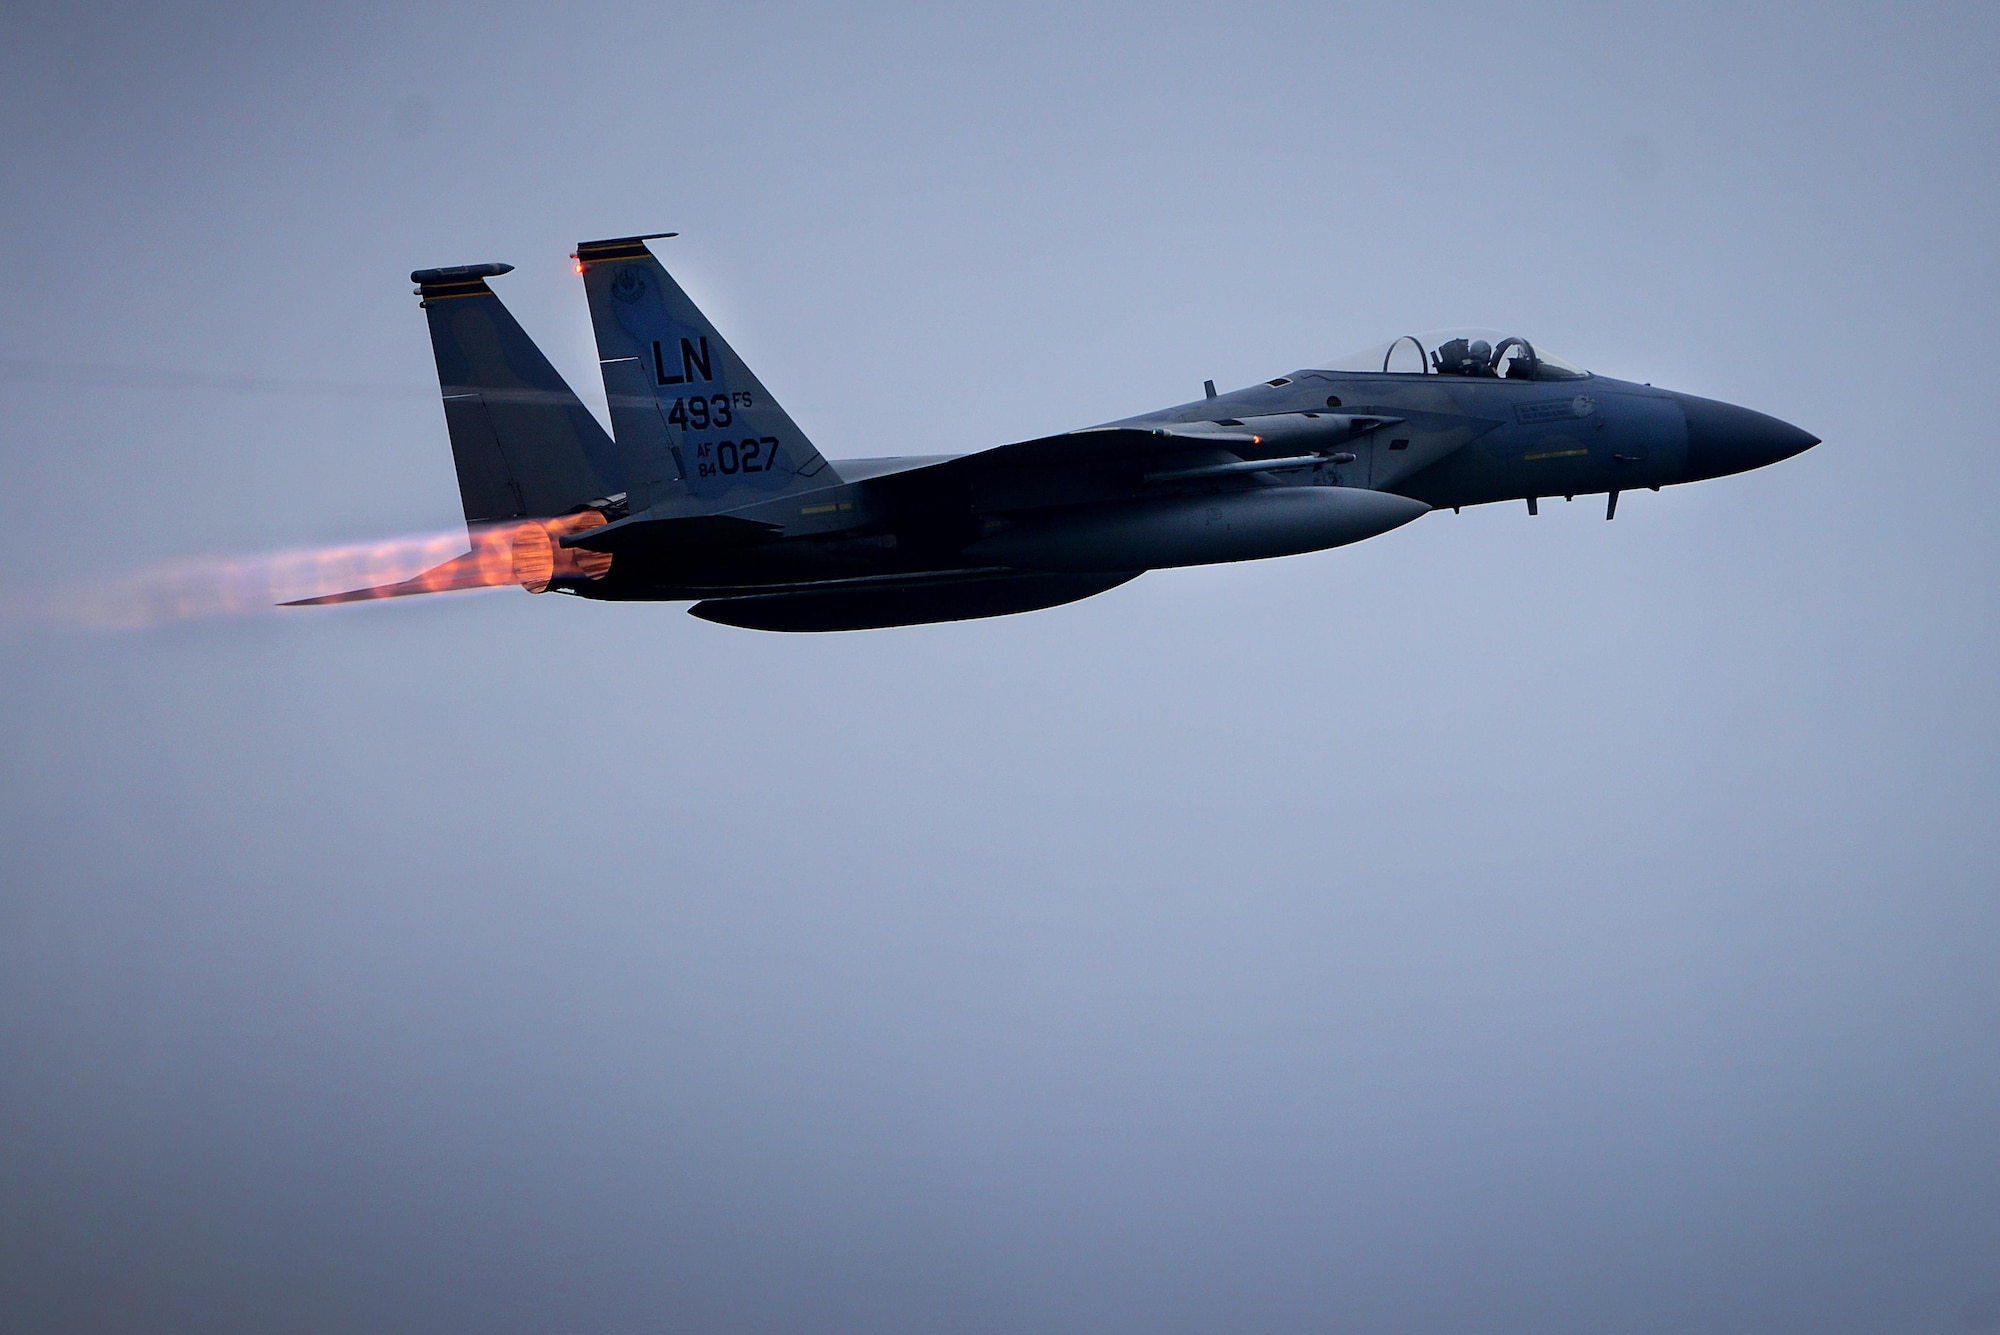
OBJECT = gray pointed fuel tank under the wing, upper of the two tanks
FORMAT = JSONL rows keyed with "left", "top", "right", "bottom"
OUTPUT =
{"left": 966, "top": 488, "right": 1430, "bottom": 572}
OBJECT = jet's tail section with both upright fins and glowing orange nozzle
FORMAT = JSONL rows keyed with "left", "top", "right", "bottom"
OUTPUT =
{"left": 282, "top": 238, "right": 840, "bottom": 604}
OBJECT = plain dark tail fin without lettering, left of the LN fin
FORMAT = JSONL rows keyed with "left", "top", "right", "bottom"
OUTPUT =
{"left": 410, "top": 264, "right": 624, "bottom": 526}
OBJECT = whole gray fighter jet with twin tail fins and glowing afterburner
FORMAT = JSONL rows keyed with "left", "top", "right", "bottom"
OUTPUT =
{"left": 292, "top": 232, "right": 1820, "bottom": 632}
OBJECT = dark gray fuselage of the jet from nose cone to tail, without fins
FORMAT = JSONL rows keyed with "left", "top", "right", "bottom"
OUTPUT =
{"left": 572, "top": 359, "right": 1818, "bottom": 600}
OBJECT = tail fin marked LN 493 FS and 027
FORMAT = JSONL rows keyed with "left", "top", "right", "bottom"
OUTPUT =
{"left": 576, "top": 236, "right": 840, "bottom": 514}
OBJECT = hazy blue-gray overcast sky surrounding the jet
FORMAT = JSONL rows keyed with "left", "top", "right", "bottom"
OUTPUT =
{"left": 0, "top": 2, "right": 2000, "bottom": 1335}
